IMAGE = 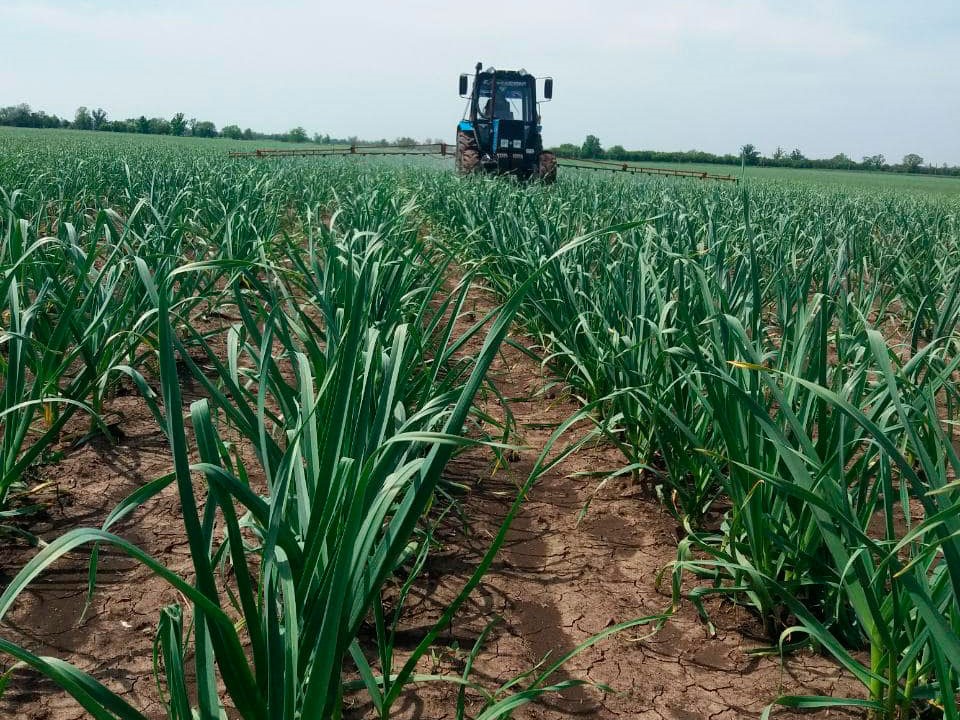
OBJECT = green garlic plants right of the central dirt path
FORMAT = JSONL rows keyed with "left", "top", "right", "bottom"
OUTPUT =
{"left": 430, "top": 172, "right": 960, "bottom": 718}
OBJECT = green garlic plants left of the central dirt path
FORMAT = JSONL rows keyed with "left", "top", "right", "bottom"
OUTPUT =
{"left": 0, "top": 138, "right": 616, "bottom": 720}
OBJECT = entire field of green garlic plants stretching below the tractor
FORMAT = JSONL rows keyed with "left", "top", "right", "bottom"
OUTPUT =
{"left": 0, "top": 126, "right": 960, "bottom": 720}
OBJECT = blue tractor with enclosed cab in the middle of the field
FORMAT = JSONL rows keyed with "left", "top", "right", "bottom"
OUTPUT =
{"left": 456, "top": 63, "right": 557, "bottom": 183}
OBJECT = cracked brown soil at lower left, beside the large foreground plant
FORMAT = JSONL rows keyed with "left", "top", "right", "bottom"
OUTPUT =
{"left": 0, "top": 390, "right": 191, "bottom": 720}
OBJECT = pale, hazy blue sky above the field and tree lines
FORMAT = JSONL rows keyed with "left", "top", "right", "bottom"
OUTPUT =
{"left": 0, "top": 0, "right": 960, "bottom": 165}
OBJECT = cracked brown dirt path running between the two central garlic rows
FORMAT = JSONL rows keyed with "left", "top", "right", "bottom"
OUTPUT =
{"left": 355, "top": 278, "right": 863, "bottom": 720}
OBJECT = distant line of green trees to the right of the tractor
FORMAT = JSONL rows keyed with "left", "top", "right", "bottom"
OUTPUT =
{"left": 552, "top": 135, "right": 960, "bottom": 177}
